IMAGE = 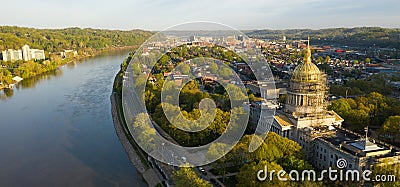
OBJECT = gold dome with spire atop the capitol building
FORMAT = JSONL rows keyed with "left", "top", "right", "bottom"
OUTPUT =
{"left": 292, "top": 38, "right": 321, "bottom": 82}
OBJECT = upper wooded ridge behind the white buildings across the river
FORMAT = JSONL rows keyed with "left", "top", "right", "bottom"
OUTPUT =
{"left": 0, "top": 26, "right": 152, "bottom": 52}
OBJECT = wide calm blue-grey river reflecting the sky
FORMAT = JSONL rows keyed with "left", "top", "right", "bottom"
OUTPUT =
{"left": 0, "top": 51, "right": 145, "bottom": 187}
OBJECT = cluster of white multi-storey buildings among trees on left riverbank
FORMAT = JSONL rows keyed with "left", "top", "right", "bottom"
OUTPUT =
{"left": 1, "top": 45, "right": 45, "bottom": 61}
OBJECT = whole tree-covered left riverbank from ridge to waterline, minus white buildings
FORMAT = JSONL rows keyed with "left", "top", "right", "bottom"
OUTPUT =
{"left": 0, "top": 26, "right": 152, "bottom": 86}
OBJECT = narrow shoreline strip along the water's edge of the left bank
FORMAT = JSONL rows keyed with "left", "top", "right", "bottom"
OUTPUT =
{"left": 0, "top": 46, "right": 138, "bottom": 90}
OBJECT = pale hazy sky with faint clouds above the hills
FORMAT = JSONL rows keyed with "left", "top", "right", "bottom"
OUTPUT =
{"left": 0, "top": 0, "right": 400, "bottom": 30}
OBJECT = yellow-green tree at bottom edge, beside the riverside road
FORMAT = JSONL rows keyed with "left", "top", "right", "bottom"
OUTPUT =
{"left": 172, "top": 165, "right": 212, "bottom": 187}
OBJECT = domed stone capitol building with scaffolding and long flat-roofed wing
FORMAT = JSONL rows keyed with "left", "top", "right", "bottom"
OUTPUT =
{"left": 270, "top": 40, "right": 400, "bottom": 171}
